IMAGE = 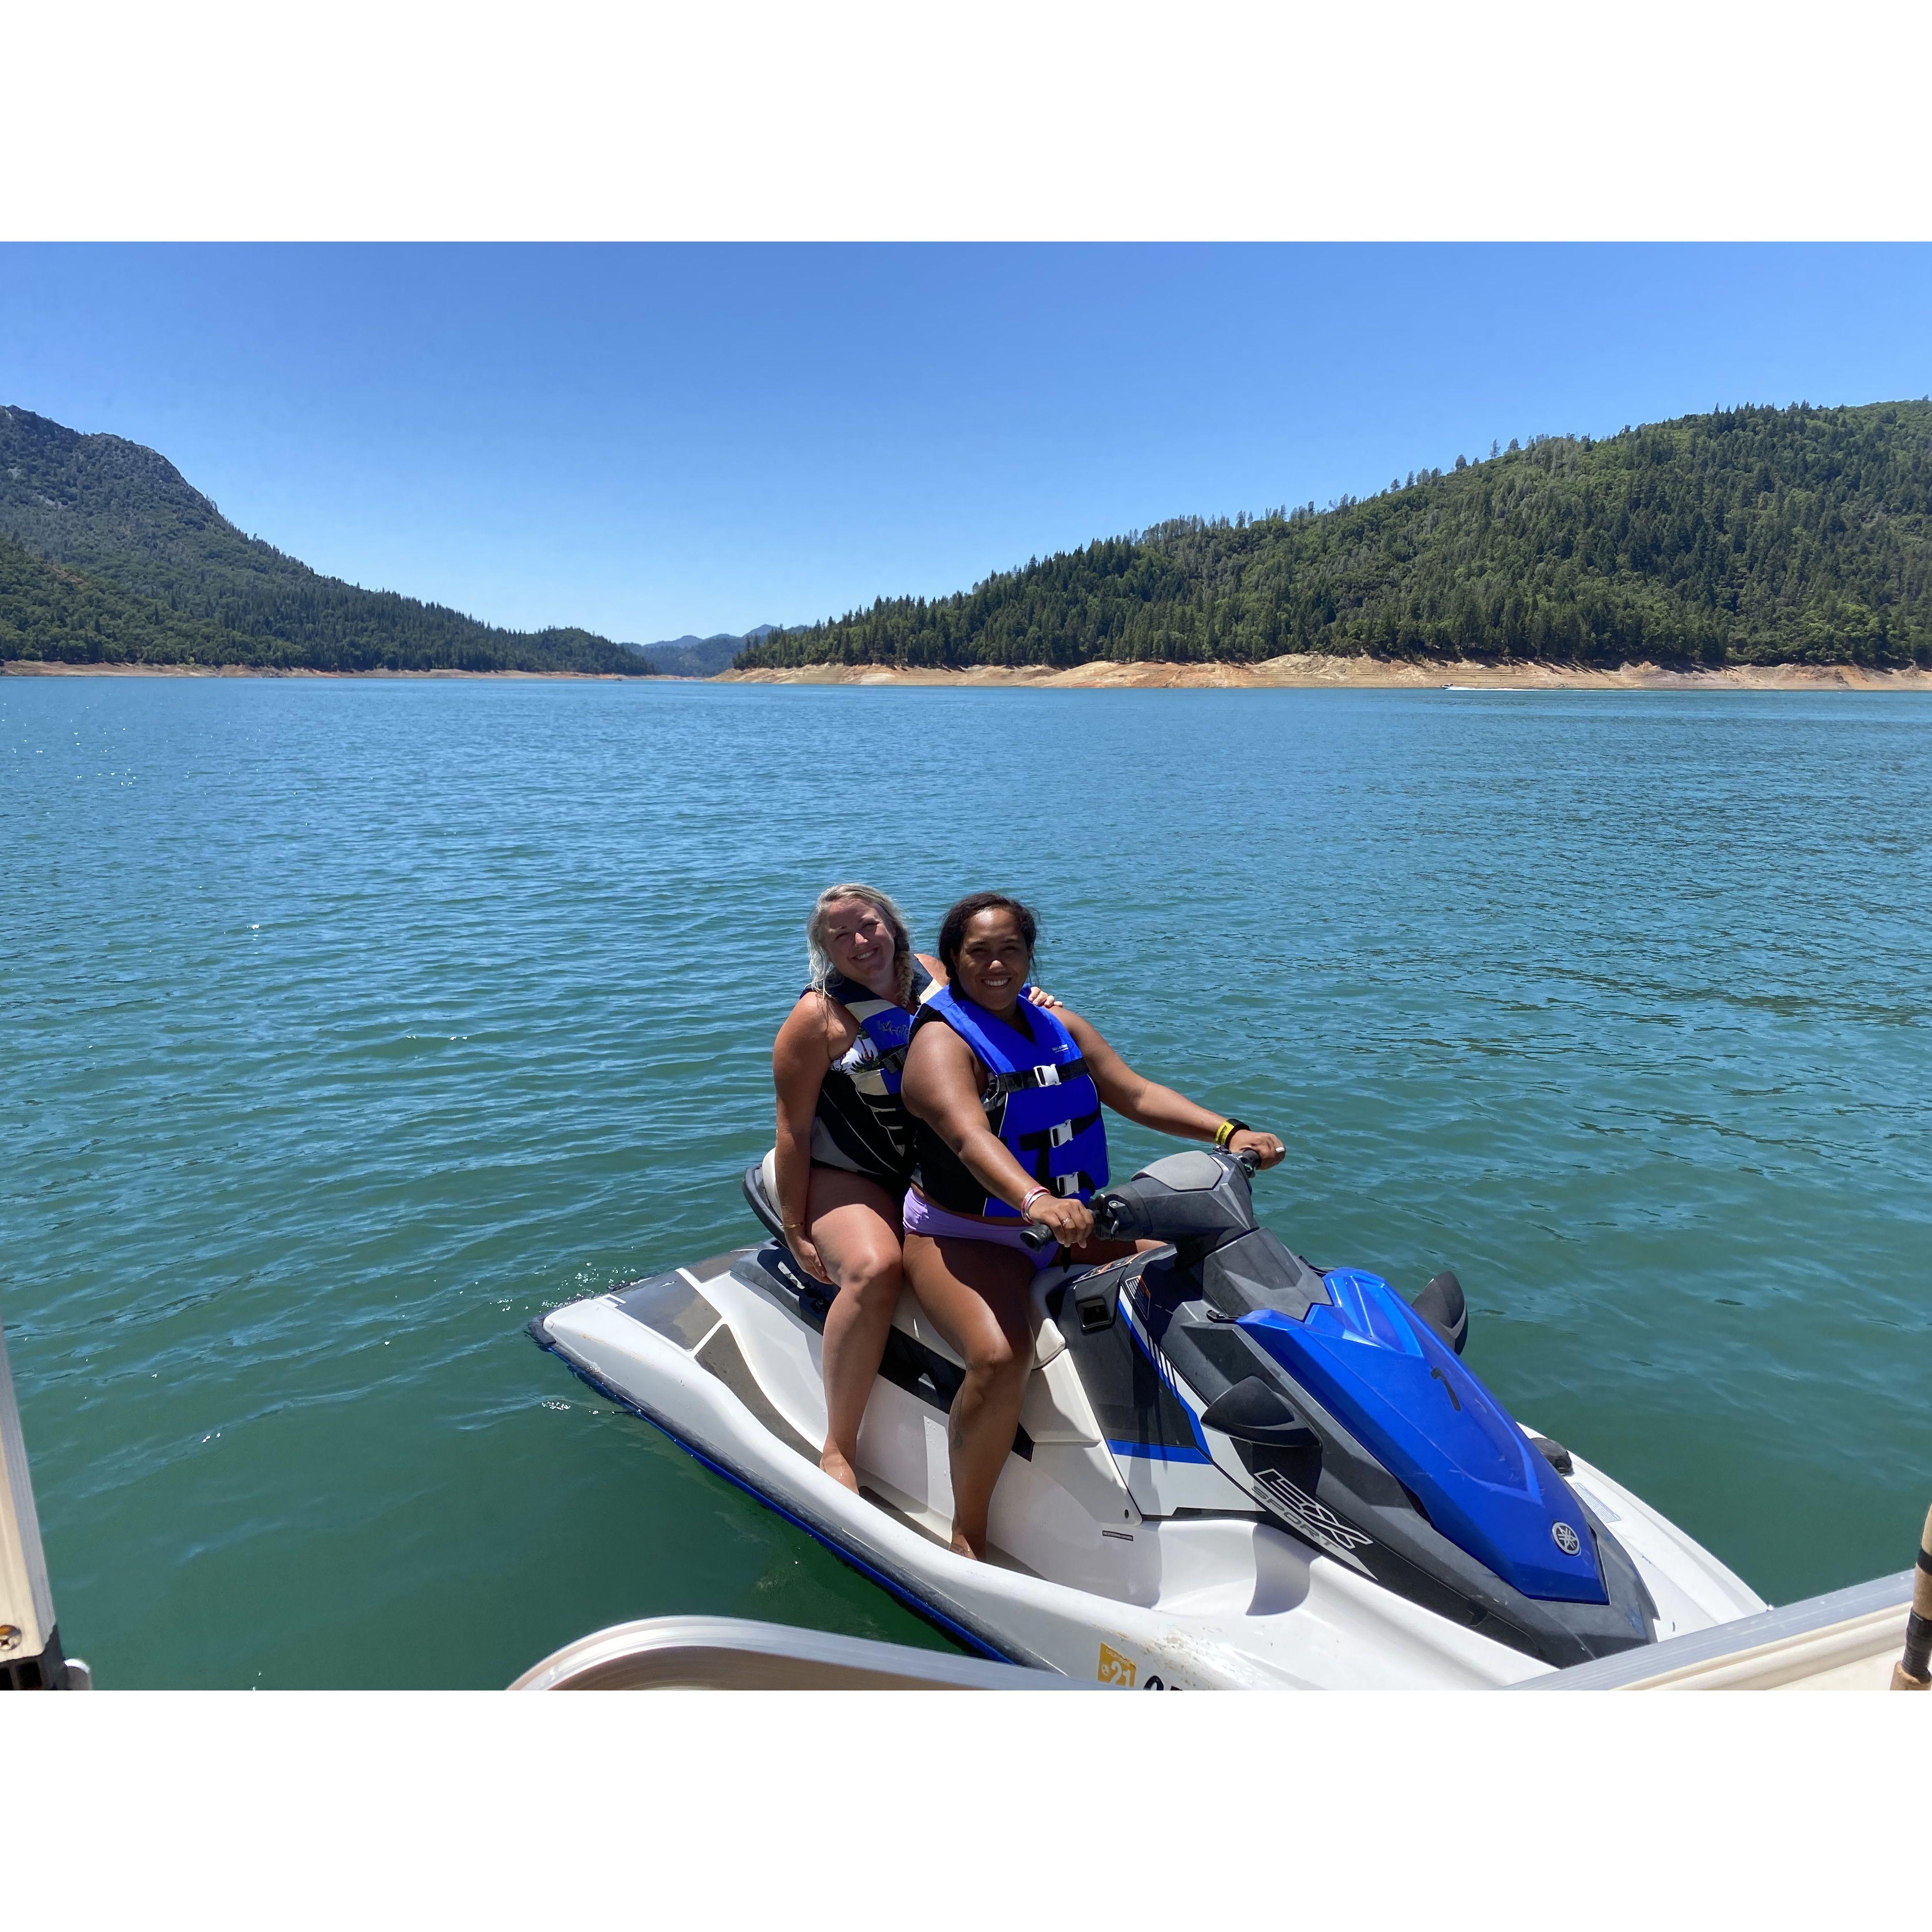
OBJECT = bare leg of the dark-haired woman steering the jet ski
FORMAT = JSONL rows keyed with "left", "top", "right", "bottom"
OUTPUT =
{"left": 906, "top": 1234, "right": 1034, "bottom": 1557}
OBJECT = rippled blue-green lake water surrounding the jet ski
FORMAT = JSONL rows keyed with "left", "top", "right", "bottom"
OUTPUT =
{"left": 0, "top": 678, "right": 1932, "bottom": 1685}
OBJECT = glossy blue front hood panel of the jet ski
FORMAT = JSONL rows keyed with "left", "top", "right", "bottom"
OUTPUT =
{"left": 1241, "top": 1267, "right": 1610, "bottom": 1604}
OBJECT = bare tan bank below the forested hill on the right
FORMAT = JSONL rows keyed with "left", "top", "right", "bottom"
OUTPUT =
{"left": 709, "top": 657, "right": 1932, "bottom": 691}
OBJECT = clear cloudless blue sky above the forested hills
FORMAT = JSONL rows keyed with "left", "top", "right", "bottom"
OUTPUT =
{"left": 0, "top": 243, "right": 1932, "bottom": 642}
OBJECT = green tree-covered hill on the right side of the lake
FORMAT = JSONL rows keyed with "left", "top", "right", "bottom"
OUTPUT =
{"left": 738, "top": 402, "right": 1932, "bottom": 667}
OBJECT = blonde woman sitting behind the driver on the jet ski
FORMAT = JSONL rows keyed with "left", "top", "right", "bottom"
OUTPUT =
{"left": 771, "top": 881, "right": 1057, "bottom": 1490}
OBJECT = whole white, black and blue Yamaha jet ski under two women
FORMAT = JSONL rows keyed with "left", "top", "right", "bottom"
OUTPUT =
{"left": 531, "top": 1150, "right": 1766, "bottom": 1690}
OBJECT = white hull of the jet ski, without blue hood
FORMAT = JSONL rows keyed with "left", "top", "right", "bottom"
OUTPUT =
{"left": 531, "top": 1248, "right": 1764, "bottom": 1689}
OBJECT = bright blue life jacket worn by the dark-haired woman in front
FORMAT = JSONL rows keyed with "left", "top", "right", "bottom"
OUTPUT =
{"left": 912, "top": 987, "right": 1107, "bottom": 1221}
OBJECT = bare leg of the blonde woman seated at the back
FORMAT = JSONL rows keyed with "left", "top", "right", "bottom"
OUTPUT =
{"left": 805, "top": 1167, "right": 904, "bottom": 1492}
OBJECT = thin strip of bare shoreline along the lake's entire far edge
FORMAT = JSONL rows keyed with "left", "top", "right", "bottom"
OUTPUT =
{"left": 15, "top": 657, "right": 1932, "bottom": 691}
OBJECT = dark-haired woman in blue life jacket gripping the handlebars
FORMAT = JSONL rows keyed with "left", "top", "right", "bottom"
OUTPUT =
{"left": 902, "top": 893, "right": 1287, "bottom": 1557}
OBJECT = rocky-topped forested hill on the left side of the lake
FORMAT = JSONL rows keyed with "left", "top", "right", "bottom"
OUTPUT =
{"left": 0, "top": 408, "right": 651, "bottom": 676}
